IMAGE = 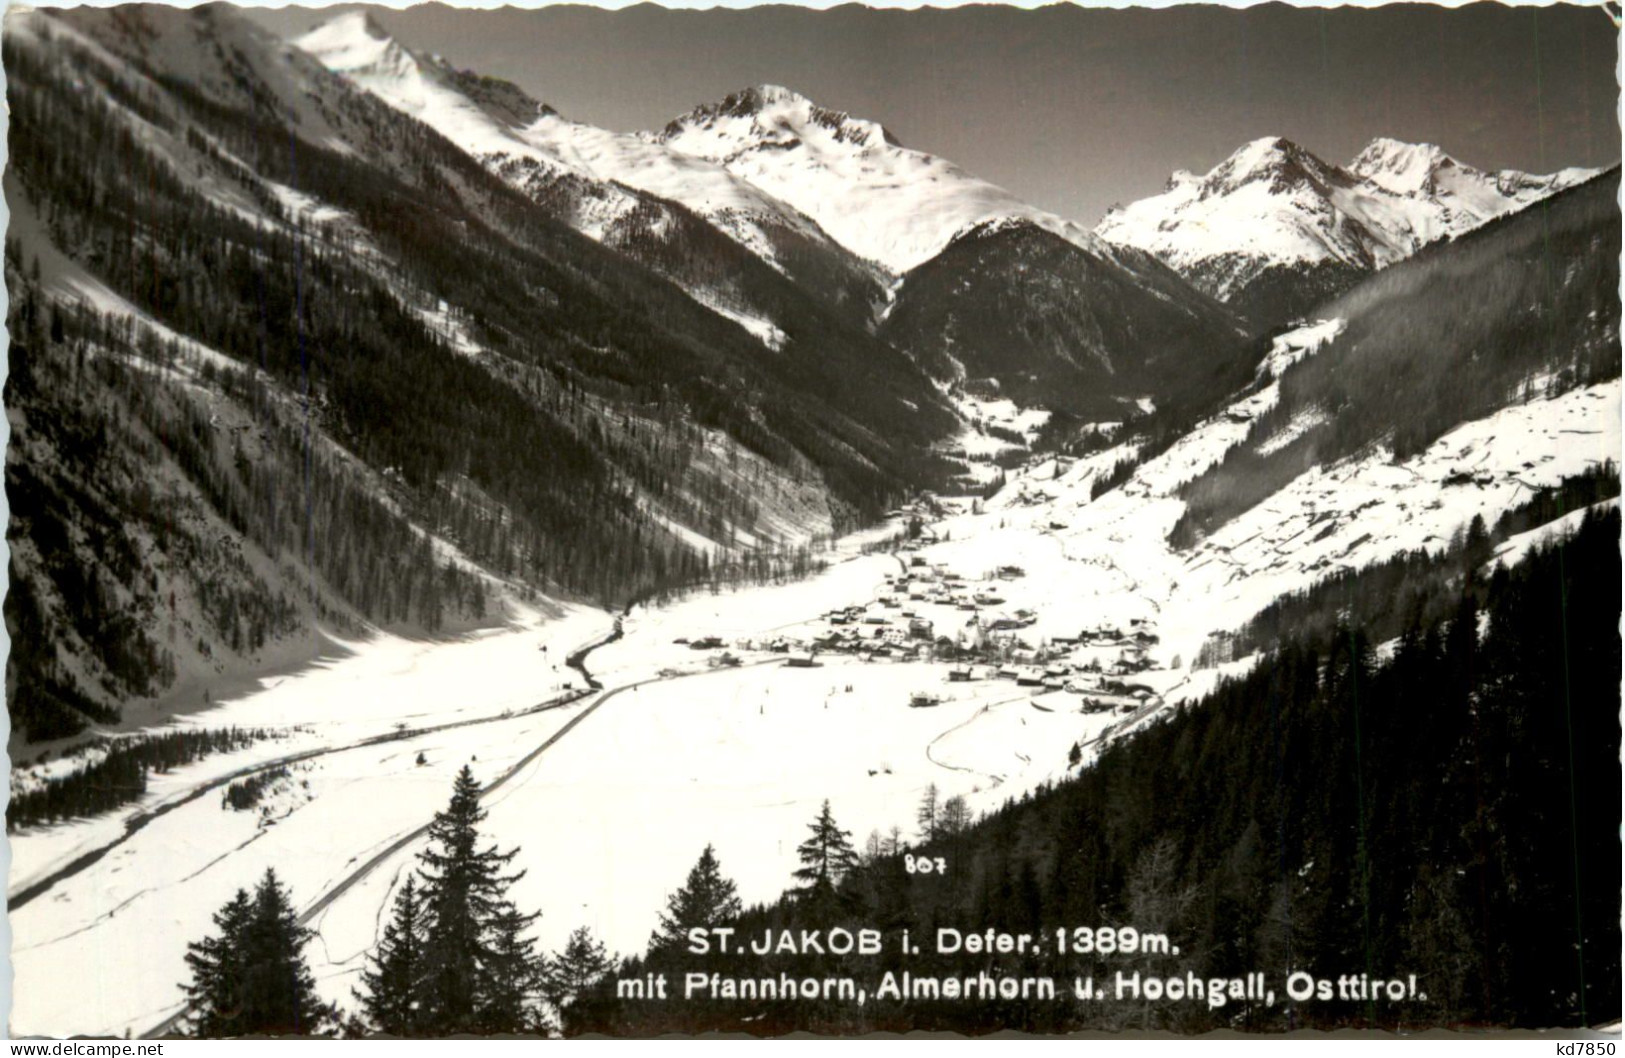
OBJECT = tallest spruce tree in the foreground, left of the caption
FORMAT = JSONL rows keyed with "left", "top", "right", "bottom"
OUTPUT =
{"left": 419, "top": 764, "right": 536, "bottom": 1035}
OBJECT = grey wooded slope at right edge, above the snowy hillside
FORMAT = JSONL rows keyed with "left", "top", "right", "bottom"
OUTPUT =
{"left": 1172, "top": 167, "right": 1620, "bottom": 546}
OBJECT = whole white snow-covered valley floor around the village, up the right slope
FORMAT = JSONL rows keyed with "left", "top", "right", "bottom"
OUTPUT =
{"left": 8, "top": 354, "right": 1620, "bottom": 1035}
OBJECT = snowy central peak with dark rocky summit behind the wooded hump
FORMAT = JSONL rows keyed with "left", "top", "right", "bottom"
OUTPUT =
{"left": 658, "top": 85, "right": 1110, "bottom": 275}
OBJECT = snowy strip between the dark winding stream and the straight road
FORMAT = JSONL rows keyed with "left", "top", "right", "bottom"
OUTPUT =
{"left": 11, "top": 709, "right": 594, "bottom": 1035}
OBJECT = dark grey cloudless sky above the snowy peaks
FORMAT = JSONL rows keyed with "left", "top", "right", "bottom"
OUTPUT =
{"left": 254, "top": 3, "right": 1620, "bottom": 224}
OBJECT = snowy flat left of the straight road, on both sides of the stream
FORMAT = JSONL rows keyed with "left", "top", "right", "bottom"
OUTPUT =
{"left": 8, "top": 608, "right": 613, "bottom": 1035}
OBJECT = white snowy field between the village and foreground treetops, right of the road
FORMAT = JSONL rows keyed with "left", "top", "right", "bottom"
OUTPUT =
{"left": 305, "top": 660, "right": 1113, "bottom": 998}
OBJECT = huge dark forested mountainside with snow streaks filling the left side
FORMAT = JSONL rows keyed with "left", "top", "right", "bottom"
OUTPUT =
{"left": 5, "top": 7, "right": 954, "bottom": 733}
